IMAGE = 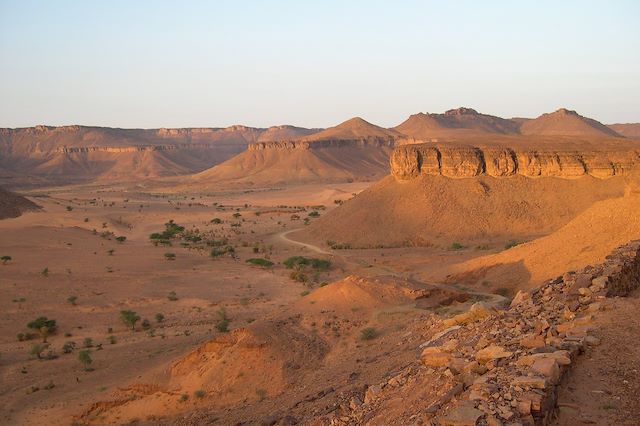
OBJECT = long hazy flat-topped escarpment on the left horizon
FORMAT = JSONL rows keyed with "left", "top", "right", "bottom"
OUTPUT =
{"left": 0, "top": 126, "right": 315, "bottom": 185}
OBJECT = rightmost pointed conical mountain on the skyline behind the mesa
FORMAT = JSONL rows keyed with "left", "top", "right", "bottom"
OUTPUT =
{"left": 520, "top": 108, "right": 621, "bottom": 137}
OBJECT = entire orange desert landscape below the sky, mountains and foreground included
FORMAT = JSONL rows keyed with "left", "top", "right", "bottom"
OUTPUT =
{"left": 0, "top": 104, "right": 640, "bottom": 425}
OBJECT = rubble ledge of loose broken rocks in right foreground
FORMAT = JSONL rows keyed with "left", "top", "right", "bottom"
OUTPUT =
{"left": 327, "top": 241, "right": 640, "bottom": 426}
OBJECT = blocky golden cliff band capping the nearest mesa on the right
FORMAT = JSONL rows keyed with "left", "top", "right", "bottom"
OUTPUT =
{"left": 389, "top": 144, "right": 640, "bottom": 180}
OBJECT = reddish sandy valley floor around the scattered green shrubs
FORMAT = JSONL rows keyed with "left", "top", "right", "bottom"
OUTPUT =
{"left": 0, "top": 183, "right": 636, "bottom": 425}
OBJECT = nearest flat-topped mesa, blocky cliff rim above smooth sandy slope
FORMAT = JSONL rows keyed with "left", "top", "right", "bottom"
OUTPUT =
{"left": 305, "top": 145, "right": 638, "bottom": 247}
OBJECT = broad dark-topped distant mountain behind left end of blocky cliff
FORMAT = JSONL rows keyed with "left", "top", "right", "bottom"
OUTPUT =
{"left": 394, "top": 108, "right": 519, "bottom": 139}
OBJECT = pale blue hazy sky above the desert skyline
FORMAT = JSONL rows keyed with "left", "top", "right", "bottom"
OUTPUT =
{"left": 0, "top": 0, "right": 640, "bottom": 127}
